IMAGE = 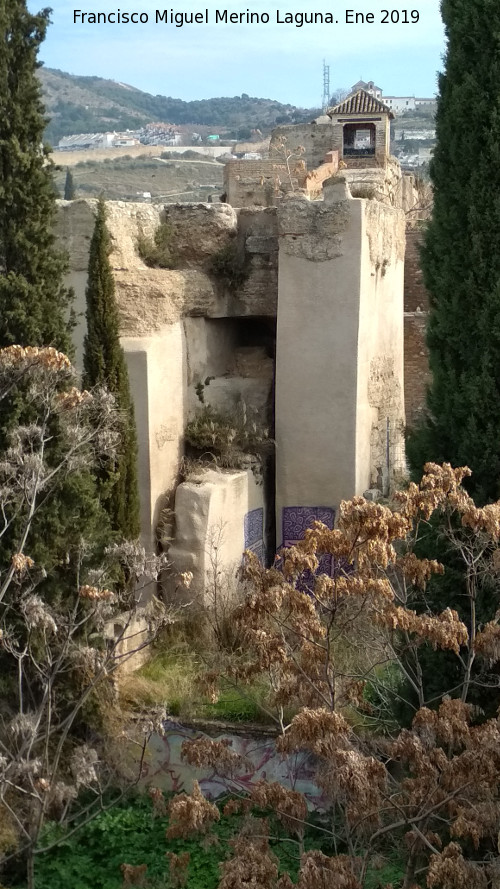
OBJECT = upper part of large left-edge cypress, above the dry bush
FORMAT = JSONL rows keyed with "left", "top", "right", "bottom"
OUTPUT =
{"left": 0, "top": 0, "right": 71, "bottom": 353}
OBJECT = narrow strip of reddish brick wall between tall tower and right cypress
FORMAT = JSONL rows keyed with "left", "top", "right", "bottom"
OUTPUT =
{"left": 404, "top": 229, "right": 430, "bottom": 426}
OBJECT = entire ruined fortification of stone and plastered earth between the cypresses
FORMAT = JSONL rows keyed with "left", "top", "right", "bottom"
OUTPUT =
{"left": 54, "top": 114, "right": 422, "bottom": 597}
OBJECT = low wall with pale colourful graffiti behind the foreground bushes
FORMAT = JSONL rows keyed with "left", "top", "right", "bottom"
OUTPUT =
{"left": 143, "top": 720, "right": 326, "bottom": 810}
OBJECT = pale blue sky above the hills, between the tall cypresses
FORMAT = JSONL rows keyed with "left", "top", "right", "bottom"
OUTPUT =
{"left": 34, "top": 0, "right": 444, "bottom": 107}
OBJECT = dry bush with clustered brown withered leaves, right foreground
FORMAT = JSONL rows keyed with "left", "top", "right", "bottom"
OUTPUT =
{"left": 171, "top": 464, "right": 500, "bottom": 889}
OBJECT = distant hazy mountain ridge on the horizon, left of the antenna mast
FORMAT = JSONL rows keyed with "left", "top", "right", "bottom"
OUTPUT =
{"left": 39, "top": 67, "right": 318, "bottom": 145}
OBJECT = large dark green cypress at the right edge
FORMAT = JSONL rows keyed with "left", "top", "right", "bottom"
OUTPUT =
{"left": 408, "top": 0, "right": 500, "bottom": 504}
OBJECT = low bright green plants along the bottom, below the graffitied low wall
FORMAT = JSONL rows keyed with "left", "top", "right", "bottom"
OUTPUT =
{"left": 28, "top": 795, "right": 403, "bottom": 889}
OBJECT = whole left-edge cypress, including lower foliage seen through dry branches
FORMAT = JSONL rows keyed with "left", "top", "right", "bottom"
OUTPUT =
{"left": 0, "top": 0, "right": 110, "bottom": 596}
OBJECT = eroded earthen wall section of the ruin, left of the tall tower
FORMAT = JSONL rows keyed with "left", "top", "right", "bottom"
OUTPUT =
{"left": 57, "top": 200, "right": 278, "bottom": 548}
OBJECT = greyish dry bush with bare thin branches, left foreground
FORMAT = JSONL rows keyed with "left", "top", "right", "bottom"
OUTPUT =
{"left": 0, "top": 346, "right": 171, "bottom": 889}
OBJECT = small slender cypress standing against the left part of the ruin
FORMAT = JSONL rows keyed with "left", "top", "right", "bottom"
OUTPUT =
{"left": 83, "top": 199, "right": 140, "bottom": 538}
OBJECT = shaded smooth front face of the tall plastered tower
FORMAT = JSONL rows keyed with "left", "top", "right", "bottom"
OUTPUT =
{"left": 275, "top": 183, "right": 363, "bottom": 545}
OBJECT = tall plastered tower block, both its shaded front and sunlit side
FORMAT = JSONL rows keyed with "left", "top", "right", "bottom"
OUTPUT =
{"left": 276, "top": 177, "right": 405, "bottom": 544}
